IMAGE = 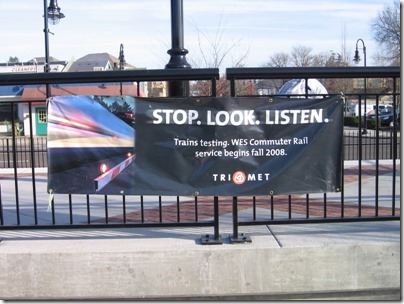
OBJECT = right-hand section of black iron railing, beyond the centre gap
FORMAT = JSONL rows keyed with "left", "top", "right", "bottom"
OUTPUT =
{"left": 227, "top": 67, "right": 400, "bottom": 242}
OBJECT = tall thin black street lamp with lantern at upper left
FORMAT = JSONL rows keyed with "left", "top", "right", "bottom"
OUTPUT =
{"left": 43, "top": 0, "right": 65, "bottom": 98}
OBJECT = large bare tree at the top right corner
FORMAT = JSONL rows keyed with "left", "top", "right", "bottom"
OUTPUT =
{"left": 371, "top": 0, "right": 401, "bottom": 66}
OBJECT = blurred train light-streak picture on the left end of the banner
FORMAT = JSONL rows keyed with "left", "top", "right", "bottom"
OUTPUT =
{"left": 48, "top": 96, "right": 135, "bottom": 194}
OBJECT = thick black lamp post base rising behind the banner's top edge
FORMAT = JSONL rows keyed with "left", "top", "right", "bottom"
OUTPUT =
{"left": 165, "top": 0, "right": 191, "bottom": 96}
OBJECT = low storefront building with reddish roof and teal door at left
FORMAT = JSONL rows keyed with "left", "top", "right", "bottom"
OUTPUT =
{"left": 0, "top": 53, "right": 147, "bottom": 136}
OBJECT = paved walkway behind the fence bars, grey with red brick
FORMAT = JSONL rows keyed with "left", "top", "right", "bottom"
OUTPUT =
{"left": 0, "top": 161, "right": 401, "bottom": 235}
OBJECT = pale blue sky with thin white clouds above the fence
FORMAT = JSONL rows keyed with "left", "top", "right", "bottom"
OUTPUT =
{"left": 0, "top": 0, "right": 393, "bottom": 69}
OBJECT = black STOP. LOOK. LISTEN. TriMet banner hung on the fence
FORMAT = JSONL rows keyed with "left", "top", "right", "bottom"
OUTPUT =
{"left": 48, "top": 96, "right": 343, "bottom": 196}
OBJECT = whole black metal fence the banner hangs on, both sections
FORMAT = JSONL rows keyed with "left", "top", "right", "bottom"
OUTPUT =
{"left": 0, "top": 67, "right": 401, "bottom": 244}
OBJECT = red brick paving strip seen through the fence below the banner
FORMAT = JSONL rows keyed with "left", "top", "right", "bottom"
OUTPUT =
{"left": 97, "top": 165, "right": 400, "bottom": 223}
